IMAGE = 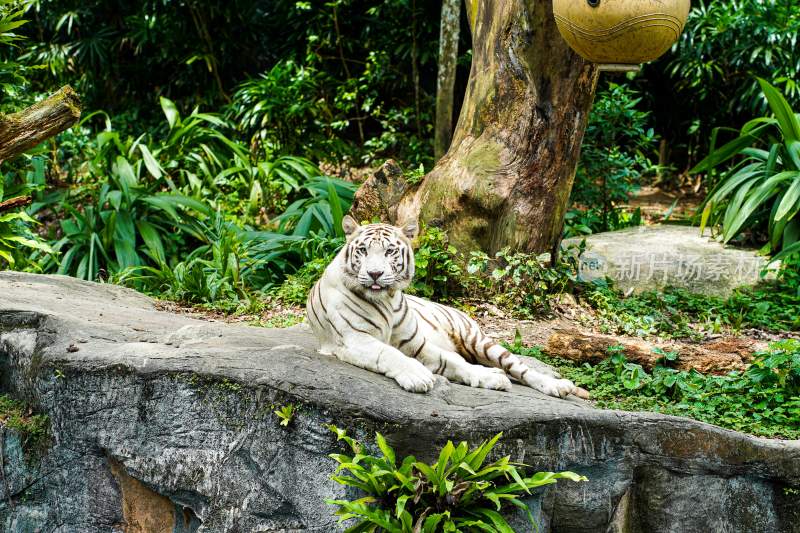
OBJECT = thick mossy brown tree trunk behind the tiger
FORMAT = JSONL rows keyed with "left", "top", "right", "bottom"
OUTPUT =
{"left": 398, "top": 0, "right": 598, "bottom": 253}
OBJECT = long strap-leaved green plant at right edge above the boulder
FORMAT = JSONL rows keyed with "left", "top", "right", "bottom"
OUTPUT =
{"left": 692, "top": 79, "right": 800, "bottom": 252}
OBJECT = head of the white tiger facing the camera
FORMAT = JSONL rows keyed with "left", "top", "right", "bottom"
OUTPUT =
{"left": 342, "top": 215, "right": 417, "bottom": 296}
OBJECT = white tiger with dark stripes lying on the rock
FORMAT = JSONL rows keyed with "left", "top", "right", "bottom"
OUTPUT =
{"left": 306, "top": 216, "right": 583, "bottom": 398}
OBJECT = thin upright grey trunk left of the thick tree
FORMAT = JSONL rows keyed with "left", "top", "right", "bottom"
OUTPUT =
{"left": 433, "top": 0, "right": 461, "bottom": 160}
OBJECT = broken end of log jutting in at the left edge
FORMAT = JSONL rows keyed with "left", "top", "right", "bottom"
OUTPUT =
{"left": 0, "top": 85, "right": 81, "bottom": 163}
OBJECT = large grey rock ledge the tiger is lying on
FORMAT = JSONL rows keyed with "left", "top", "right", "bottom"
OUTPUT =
{"left": 0, "top": 273, "right": 800, "bottom": 533}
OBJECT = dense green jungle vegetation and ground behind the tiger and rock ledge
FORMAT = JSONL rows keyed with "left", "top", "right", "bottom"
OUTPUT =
{"left": 0, "top": 0, "right": 800, "bottom": 438}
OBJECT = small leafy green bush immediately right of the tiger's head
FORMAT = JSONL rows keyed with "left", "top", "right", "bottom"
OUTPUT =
{"left": 410, "top": 227, "right": 461, "bottom": 300}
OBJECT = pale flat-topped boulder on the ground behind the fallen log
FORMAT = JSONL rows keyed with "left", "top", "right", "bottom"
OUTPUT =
{"left": 565, "top": 224, "right": 767, "bottom": 297}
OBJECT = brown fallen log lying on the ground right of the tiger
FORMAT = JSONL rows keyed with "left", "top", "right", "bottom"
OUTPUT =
{"left": 545, "top": 329, "right": 763, "bottom": 374}
